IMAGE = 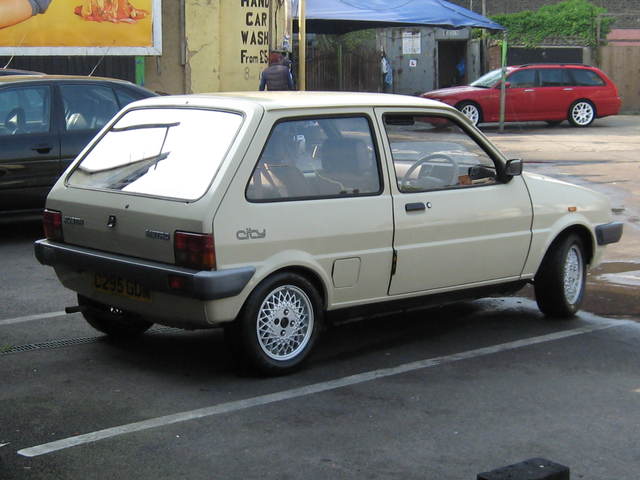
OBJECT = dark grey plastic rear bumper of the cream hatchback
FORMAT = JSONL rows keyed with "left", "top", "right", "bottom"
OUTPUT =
{"left": 34, "top": 239, "right": 256, "bottom": 300}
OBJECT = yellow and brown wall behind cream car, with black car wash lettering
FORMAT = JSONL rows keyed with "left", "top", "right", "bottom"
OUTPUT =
{"left": 145, "top": 0, "right": 286, "bottom": 93}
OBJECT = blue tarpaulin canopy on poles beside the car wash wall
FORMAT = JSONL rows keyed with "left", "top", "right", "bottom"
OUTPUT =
{"left": 293, "top": 0, "right": 504, "bottom": 33}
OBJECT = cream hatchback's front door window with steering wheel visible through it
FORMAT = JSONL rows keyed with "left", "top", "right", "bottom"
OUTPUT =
{"left": 384, "top": 114, "right": 497, "bottom": 193}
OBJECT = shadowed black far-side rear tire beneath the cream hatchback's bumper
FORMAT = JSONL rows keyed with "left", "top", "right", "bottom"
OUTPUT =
{"left": 78, "top": 295, "right": 153, "bottom": 338}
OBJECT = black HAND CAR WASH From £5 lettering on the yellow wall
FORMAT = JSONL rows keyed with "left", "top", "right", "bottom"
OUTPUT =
{"left": 240, "top": 0, "right": 269, "bottom": 65}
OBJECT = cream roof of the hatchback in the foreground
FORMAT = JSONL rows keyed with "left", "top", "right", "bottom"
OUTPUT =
{"left": 126, "top": 91, "right": 450, "bottom": 110}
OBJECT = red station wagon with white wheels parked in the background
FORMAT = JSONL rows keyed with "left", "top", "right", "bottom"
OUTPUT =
{"left": 422, "top": 64, "right": 622, "bottom": 127}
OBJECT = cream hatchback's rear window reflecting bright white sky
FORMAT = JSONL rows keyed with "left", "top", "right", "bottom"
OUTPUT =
{"left": 67, "top": 108, "right": 242, "bottom": 200}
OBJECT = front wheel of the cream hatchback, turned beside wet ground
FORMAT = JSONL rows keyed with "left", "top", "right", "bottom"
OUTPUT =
{"left": 534, "top": 234, "right": 587, "bottom": 318}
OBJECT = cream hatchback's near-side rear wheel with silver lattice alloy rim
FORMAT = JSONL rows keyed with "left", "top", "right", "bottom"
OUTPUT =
{"left": 232, "top": 272, "right": 324, "bottom": 375}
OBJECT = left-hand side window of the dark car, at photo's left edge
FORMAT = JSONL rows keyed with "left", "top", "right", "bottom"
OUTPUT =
{"left": 0, "top": 86, "right": 51, "bottom": 136}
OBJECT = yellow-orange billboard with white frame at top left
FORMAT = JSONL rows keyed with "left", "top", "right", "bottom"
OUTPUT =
{"left": 0, "top": 0, "right": 162, "bottom": 55}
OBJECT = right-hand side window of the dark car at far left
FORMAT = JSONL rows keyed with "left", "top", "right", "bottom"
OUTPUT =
{"left": 60, "top": 84, "right": 120, "bottom": 131}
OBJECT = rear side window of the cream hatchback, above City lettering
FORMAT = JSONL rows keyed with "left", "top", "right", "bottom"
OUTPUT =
{"left": 246, "top": 116, "right": 382, "bottom": 201}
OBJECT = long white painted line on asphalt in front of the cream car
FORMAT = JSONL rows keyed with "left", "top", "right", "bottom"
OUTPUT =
{"left": 18, "top": 320, "right": 636, "bottom": 457}
